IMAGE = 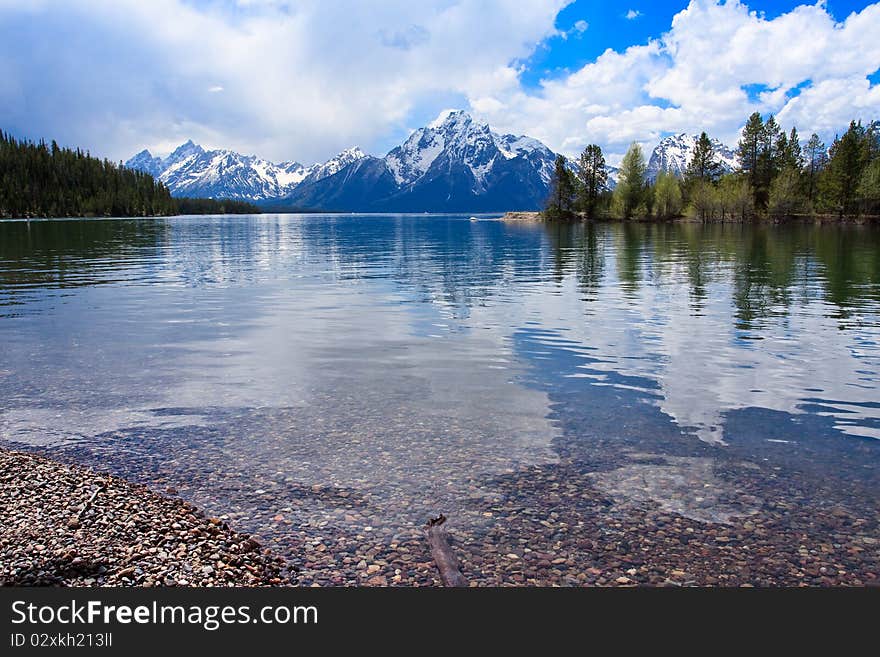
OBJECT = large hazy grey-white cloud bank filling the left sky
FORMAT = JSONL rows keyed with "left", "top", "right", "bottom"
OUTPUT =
{"left": 0, "top": 0, "right": 566, "bottom": 161}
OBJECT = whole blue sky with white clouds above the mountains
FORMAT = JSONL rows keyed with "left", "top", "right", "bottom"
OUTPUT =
{"left": 0, "top": 0, "right": 880, "bottom": 164}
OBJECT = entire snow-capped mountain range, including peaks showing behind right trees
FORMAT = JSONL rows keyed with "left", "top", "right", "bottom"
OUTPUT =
{"left": 125, "top": 110, "right": 736, "bottom": 212}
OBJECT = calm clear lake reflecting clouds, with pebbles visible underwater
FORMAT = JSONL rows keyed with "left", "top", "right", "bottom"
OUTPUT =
{"left": 0, "top": 215, "right": 880, "bottom": 584}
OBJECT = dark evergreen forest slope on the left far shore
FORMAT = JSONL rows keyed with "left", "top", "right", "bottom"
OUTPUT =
{"left": 0, "top": 130, "right": 259, "bottom": 218}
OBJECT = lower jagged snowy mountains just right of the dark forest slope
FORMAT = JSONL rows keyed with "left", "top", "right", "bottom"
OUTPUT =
{"left": 125, "top": 140, "right": 366, "bottom": 201}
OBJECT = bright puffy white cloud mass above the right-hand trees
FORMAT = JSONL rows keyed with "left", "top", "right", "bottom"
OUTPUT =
{"left": 471, "top": 0, "right": 880, "bottom": 160}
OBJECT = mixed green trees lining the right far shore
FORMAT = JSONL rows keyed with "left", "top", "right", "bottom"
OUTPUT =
{"left": 544, "top": 112, "right": 880, "bottom": 221}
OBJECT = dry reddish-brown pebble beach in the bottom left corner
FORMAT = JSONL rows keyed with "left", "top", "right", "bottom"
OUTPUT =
{"left": 0, "top": 449, "right": 288, "bottom": 586}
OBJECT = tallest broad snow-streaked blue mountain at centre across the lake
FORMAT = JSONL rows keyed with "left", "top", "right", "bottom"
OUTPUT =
{"left": 288, "top": 110, "right": 556, "bottom": 212}
